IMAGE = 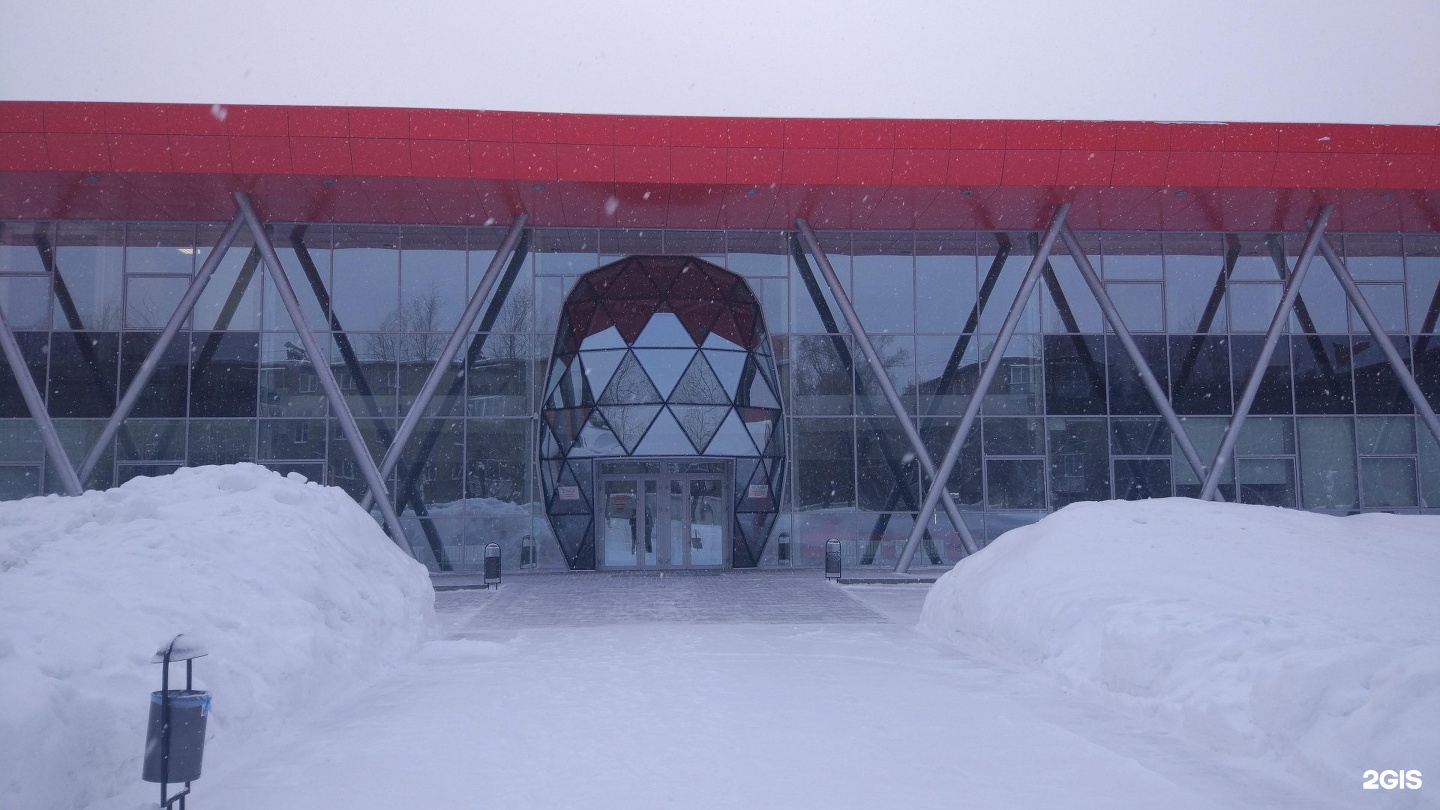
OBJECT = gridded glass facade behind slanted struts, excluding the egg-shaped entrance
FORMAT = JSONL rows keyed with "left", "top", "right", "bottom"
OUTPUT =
{"left": 0, "top": 222, "right": 1440, "bottom": 568}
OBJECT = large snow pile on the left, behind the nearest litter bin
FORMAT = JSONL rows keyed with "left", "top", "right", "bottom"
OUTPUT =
{"left": 0, "top": 464, "right": 433, "bottom": 810}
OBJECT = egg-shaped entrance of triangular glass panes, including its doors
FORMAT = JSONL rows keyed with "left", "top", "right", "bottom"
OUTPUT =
{"left": 540, "top": 257, "right": 785, "bottom": 568}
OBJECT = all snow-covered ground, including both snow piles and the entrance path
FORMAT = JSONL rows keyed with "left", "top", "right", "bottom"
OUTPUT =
{"left": 0, "top": 466, "right": 1440, "bottom": 810}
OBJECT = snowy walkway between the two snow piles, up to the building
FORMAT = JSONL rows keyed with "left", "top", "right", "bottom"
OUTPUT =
{"left": 182, "top": 571, "right": 1359, "bottom": 810}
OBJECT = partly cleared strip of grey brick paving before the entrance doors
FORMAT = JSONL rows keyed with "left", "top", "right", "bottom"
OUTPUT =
{"left": 435, "top": 571, "right": 890, "bottom": 634}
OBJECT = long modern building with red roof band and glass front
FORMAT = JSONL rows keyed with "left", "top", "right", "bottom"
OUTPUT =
{"left": 0, "top": 102, "right": 1440, "bottom": 569}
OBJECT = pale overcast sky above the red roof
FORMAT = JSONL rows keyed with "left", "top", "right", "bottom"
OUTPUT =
{"left": 0, "top": 0, "right": 1440, "bottom": 125}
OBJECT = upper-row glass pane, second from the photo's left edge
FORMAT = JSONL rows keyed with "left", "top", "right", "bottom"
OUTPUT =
{"left": 50, "top": 222, "right": 125, "bottom": 331}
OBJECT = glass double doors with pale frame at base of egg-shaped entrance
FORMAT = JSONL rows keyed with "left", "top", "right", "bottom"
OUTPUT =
{"left": 595, "top": 458, "right": 733, "bottom": 569}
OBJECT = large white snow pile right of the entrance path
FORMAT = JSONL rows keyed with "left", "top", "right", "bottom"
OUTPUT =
{"left": 920, "top": 499, "right": 1440, "bottom": 788}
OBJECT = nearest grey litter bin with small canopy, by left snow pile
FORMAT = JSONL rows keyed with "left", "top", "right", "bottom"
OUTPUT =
{"left": 141, "top": 634, "right": 210, "bottom": 810}
